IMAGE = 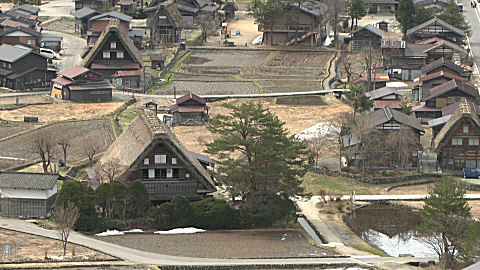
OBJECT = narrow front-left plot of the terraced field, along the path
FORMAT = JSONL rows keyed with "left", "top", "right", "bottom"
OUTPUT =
{"left": 155, "top": 81, "right": 258, "bottom": 95}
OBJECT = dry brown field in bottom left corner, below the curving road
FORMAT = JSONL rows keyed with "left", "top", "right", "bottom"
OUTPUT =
{"left": 0, "top": 229, "right": 114, "bottom": 262}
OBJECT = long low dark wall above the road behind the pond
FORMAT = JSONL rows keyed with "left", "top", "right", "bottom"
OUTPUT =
{"left": 312, "top": 168, "right": 442, "bottom": 185}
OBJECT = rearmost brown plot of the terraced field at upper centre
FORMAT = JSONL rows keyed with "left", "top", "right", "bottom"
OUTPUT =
{"left": 183, "top": 50, "right": 270, "bottom": 67}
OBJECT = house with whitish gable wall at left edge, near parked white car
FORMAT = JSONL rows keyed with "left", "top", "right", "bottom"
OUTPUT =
{"left": 0, "top": 26, "right": 42, "bottom": 48}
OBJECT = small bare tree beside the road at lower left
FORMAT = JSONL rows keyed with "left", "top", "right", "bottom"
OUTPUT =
{"left": 53, "top": 202, "right": 80, "bottom": 256}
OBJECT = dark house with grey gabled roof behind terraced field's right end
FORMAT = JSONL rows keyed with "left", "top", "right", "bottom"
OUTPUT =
{"left": 352, "top": 24, "right": 385, "bottom": 51}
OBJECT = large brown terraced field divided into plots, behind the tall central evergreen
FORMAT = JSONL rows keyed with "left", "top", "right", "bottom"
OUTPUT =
{"left": 155, "top": 50, "right": 333, "bottom": 95}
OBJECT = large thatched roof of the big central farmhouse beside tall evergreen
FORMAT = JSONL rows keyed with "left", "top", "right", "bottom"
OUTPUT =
{"left": 95, "top": 109, "right": 216, "bottom": 192}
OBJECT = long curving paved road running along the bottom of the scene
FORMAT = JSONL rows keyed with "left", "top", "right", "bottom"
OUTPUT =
{"left": 0, "top": 217, "right": 435, "bottom": 266}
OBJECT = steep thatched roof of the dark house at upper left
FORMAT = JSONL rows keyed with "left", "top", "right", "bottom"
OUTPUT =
{"left": 82, "top": 18, "right": 143, "bottom": 67}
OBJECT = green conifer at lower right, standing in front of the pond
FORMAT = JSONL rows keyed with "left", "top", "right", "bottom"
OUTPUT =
{"left": 421, "top": 177, "right": 472, "bottom": 268}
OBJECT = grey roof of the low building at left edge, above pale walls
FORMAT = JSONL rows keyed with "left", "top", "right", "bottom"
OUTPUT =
{"left": 0, "top": 172, "right": 59, "bottom": 190}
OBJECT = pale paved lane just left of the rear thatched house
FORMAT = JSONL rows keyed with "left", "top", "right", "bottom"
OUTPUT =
{"left": 43, "top": 30, "right": 87, "bottom": 71}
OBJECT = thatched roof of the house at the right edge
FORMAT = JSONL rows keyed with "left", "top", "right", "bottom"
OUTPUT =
{"left": 432, "top": 100, "right": 480, "bottom": 151}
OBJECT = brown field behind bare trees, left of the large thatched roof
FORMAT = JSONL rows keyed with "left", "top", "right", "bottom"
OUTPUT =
{"left": 0, "top": 120, "right": 114, "bottom": 164}
